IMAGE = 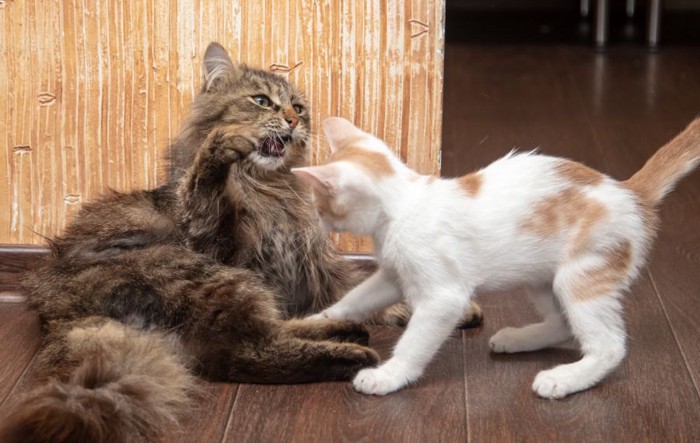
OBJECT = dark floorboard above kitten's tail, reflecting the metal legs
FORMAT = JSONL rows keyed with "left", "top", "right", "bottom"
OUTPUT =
{"left": 562, "top": 48, "right": 700, "bottom": 180}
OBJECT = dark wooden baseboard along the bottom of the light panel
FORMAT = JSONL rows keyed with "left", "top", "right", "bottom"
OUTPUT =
{"left": 0, "top": 244, "right": 376, "bottom": 303}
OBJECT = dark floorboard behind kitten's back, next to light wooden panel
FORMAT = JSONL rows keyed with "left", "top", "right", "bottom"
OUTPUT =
{"left": 442, "top": 46, "right": 608, "bottom": 177}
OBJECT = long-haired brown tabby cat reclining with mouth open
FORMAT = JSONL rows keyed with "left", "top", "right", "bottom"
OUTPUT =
{"left": 0, "top": 43, "right": 476, "bottom": 442}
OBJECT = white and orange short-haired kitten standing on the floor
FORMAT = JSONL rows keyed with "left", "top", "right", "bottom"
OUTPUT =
{"left": 293, "top": 118, "right": 700, "bottom": 398}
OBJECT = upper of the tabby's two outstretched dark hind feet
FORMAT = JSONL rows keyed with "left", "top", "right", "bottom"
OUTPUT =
{"left": 284, "top": 319, "right": 369, "bottom": 346}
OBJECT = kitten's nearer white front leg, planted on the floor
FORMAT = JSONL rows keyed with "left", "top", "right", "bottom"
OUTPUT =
{"left": 353, "top": 290, "right": 469, "bottom": 395}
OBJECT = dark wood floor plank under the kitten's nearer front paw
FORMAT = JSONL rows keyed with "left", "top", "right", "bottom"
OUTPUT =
{"left": 221, "top": 328, "right": 466, "bottom": 442}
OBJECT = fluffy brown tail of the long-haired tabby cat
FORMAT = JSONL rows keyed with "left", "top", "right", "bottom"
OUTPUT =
{"left": 0, "top": 317, "right": 194, "bottom": 443}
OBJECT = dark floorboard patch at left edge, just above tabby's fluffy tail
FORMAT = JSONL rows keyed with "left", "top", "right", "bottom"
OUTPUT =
{"left": 0, "top": 303, "right": 41, "bottom": 406}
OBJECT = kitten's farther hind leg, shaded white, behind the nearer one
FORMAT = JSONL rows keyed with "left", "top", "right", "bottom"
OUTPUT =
{"left": 489, "top": 286, "right": 571, "bottom": 353}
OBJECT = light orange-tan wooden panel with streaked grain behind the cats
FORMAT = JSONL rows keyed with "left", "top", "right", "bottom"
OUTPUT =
{"left": 0, "top": 0, "right": 444, "bottom": 251}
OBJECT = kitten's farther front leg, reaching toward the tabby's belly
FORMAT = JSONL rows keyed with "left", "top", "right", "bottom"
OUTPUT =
{"left": 308, "top": 269, "right": 401, "bottom": 322}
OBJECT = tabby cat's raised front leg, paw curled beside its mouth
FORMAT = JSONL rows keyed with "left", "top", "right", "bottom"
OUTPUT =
{"left": 179, "top": 127, "right": 257, "bottom": 259}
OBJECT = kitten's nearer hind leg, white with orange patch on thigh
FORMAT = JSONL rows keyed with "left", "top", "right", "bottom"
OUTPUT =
{"left": 532, "top": 257, "right": 627, "bottom": 398}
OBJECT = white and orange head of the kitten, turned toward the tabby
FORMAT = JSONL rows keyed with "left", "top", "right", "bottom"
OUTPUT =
{"left": 292, "top": 117, "right": 400, "bottom": 235}
